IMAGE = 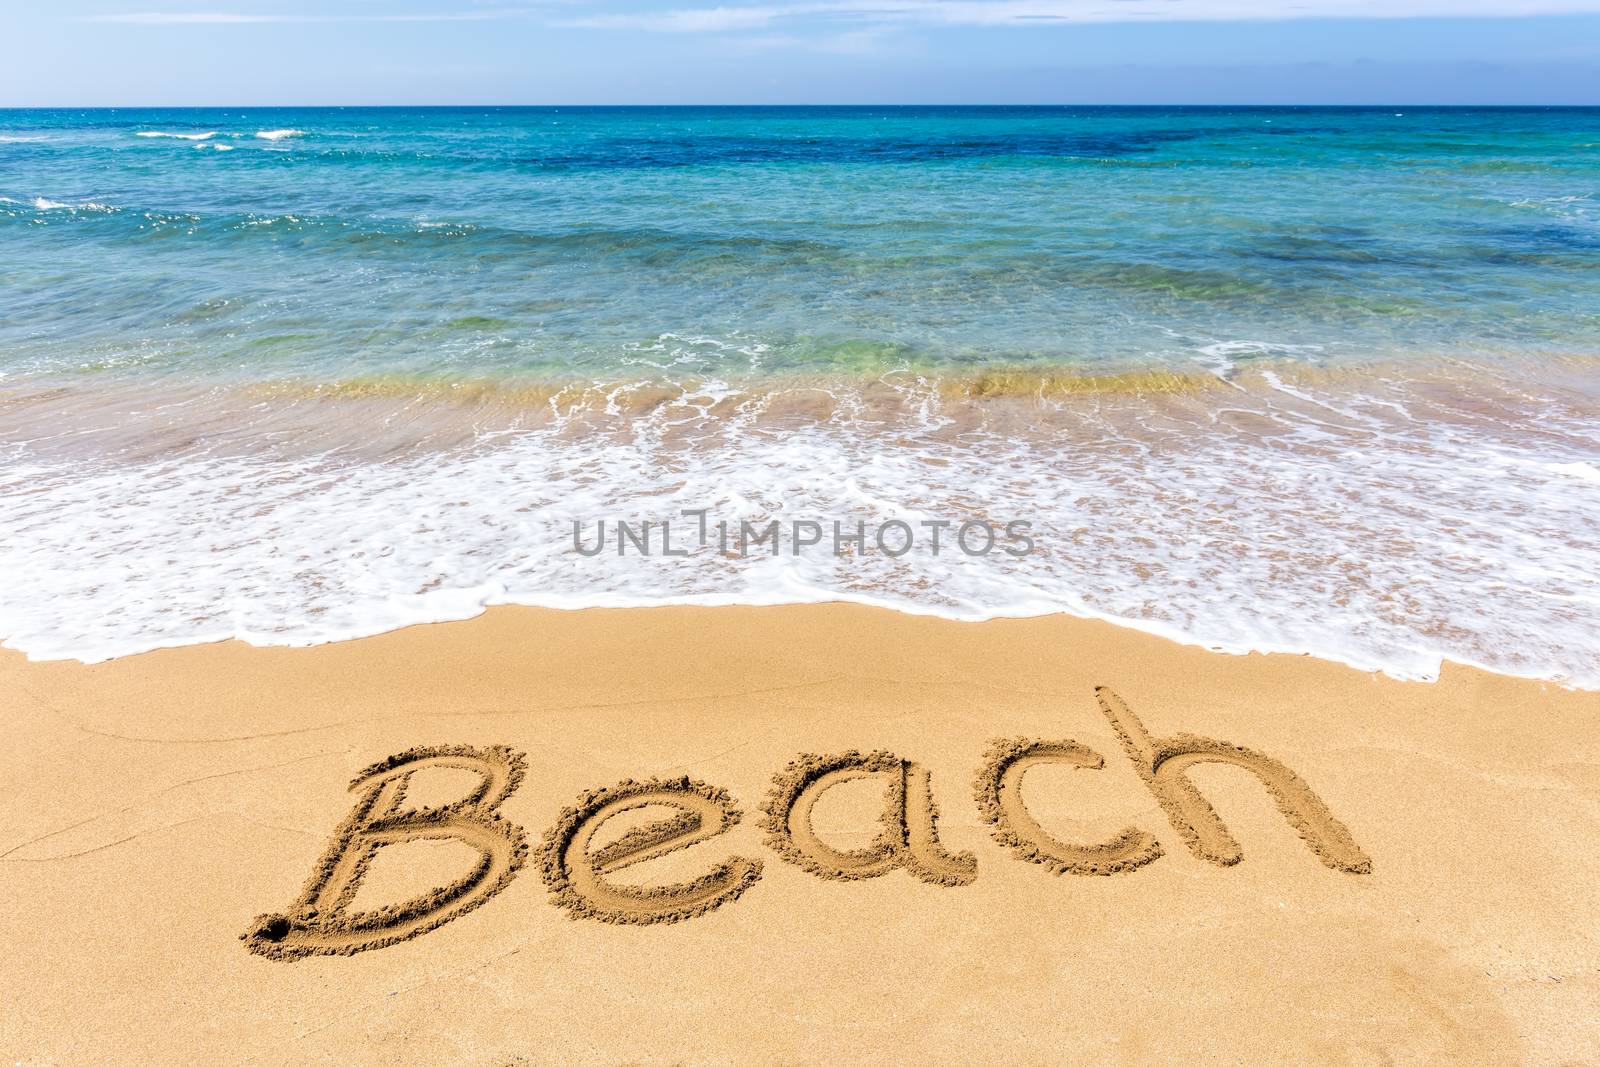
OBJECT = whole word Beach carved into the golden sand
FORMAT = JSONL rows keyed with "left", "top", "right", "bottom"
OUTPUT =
{"left": 242, "top": 688, "right": 1371, "bottom": 960}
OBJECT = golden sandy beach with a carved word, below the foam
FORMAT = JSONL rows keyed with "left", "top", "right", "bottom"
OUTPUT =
{"left": 0, "top": 605, "right": 1600, "bottom": 1067}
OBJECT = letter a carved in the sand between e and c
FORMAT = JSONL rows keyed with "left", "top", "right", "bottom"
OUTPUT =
{"left": 765, "top": 752, "right": 978, "bottom": 886}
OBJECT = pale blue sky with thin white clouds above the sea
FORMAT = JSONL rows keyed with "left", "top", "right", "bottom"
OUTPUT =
{"left": 0, "top": 0, "right": 1600, "bottom": 107}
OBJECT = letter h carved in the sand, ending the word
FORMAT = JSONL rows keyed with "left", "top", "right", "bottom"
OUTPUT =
{"left": 1094, "top": 686, "right": 1373, "bottom": 873}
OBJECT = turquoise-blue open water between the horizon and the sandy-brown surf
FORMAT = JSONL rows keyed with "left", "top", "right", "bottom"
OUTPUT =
{"left": 0, "top": 109, "right": 1600, "bottom": 378}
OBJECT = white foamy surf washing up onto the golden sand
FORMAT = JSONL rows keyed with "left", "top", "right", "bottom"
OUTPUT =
{"left": 0, "top": 364, "right": 1600, "bottom": 688}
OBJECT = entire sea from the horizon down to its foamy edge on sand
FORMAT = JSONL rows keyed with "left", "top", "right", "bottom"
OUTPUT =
{"left": 0, "top": 107, "right": 1600, "bottom": 685}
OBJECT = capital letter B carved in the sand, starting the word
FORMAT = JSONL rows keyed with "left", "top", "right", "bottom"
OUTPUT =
{"left": 242, "top": 745, "right": 528, "bottom": 960}
